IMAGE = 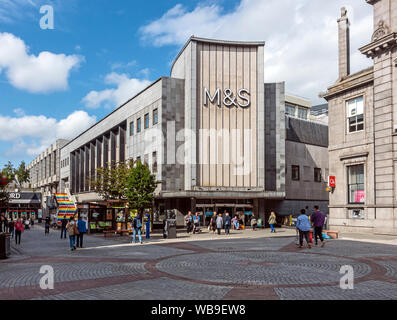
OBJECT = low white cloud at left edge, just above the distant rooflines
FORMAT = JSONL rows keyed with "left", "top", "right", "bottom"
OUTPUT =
{"left": 0, "top": 109, "right": 96, "bottom": 156}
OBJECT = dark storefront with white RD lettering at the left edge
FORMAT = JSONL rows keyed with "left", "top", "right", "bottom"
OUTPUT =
{"left": 0, "top": 192, "right": 42, "bottom": 220}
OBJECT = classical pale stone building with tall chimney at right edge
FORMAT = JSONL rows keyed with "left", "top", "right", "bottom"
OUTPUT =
{"left": 324, "top": 0, "right": 397, "bottom": 234}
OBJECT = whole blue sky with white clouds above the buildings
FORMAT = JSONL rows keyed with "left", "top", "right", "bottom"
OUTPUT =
{"left": 0, "top": 0, "right": 373, "bottom": 167}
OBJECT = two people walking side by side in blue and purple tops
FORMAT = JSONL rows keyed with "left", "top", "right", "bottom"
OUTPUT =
{"left": 296, "top": 206, "right": 326, "bottom": 249}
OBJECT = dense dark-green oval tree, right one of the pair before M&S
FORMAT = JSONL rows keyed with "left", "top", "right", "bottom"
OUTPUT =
{"left": 126, "top": 161, "right": 157, "bottom": 217}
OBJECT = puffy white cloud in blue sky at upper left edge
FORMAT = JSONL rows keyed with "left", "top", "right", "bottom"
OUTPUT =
{"left": 0, "top": 33, "right": 83, "bottom": 93}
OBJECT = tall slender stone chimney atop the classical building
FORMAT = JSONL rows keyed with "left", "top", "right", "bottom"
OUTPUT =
{"left": 338, "top": 7, "right": 350, "bottom": 80}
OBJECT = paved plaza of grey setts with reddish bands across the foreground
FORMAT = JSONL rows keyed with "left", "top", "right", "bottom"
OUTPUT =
{"left": 0, "top": 225, "right": 397, "bottom": 300}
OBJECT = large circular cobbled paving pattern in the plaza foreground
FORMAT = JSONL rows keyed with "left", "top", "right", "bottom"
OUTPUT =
{"left": 156, "top": 252, "right": 371, "bottom": 285}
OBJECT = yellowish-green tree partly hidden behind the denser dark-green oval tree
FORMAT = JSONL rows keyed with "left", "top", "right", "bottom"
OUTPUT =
{"left": 90, "top": 162, "right": 130, "bottom": 201}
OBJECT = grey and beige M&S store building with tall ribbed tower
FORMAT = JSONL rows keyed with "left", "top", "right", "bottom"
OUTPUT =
{"left": 33, "top": 37, "right": 328, "bottom": 217}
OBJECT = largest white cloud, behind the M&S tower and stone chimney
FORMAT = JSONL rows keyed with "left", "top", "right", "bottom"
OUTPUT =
{"left": 140, "top": 0, "right": 373, "bottom": 103}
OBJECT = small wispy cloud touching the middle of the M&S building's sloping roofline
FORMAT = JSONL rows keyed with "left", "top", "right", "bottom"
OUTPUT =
{"left": 82, "top": 72, "right": 151, "bottom": 108}
